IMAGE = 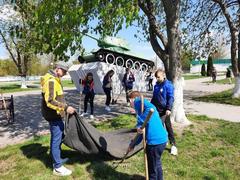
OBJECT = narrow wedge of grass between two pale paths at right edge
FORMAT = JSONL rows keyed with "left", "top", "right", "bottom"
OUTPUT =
{"left": 193, "top": 89, "right": 240, "bottom": 106}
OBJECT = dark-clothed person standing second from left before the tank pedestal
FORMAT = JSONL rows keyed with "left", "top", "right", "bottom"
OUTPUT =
{"left": 102, "top": 70, "right": 114, "bottom": 111}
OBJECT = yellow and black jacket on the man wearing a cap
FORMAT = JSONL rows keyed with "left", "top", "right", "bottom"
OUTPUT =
{"left": 41, "top": 71, "right": 67, "bottom": 121}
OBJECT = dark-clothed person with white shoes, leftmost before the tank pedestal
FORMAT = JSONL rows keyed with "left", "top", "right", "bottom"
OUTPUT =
{"left": 81, "top": 72, "right": 95, "bottom": 119}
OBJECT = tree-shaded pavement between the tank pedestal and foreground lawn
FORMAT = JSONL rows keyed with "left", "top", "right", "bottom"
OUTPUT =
{"left": 0, "top": 88, "right": 129, "bottom": 148}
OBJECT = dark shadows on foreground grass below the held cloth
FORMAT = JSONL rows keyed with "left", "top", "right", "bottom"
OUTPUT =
{"left": 20, "top": 143, "right": 145, "bottom": 180}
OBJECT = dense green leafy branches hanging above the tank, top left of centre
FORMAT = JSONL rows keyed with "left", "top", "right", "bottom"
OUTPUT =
{"left": 25, "top": 0, "right": 138, "bottom": 60}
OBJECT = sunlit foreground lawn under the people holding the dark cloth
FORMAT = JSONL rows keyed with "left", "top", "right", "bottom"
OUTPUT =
{"left": 0, "top": 115, "right": 240, "bottom": 180}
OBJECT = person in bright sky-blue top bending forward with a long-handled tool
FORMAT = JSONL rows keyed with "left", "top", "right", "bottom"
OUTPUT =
{"left": 128, "top": 91, "right": 168, "bottom": 180}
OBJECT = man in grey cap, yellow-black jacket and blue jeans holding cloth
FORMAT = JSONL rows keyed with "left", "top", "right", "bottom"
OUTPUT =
{"left": 41, "top": 62, "right": 75, "bottom": 176}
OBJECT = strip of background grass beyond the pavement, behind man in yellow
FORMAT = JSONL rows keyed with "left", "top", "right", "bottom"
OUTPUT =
{"left": 0, "top": 80, "right": 75, "bottom": 93}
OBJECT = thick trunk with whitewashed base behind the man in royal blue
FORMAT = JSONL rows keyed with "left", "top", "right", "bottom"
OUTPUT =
{"left": 162, "top": 0, "right": 190, "bottom": 124}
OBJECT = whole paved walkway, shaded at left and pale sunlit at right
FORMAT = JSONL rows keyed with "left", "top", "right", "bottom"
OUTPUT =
{"left": 0, "top": 78, "right": 240, "bottom": 147}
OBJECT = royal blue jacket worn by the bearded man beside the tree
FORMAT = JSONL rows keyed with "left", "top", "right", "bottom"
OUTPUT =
{"left": 151, "top": 79, "right": 174, "bottom": 116}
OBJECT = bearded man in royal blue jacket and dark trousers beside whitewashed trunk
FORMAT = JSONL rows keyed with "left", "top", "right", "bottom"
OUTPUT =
{"left": 151, "top": 69, "right": 177, "bottom": 156}
